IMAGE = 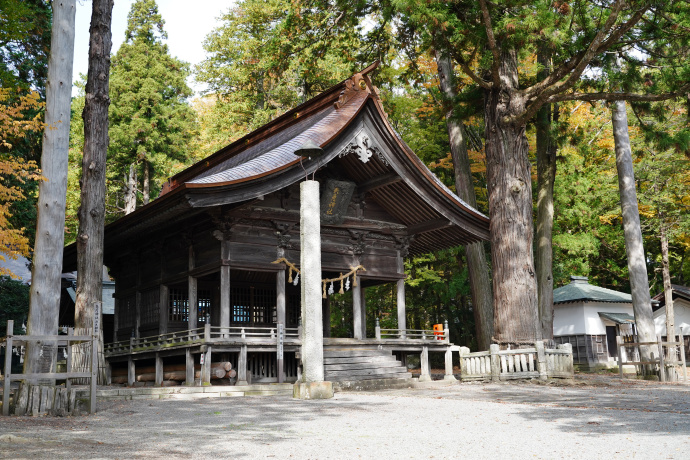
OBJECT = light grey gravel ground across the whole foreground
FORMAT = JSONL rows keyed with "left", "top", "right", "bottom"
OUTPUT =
{"left": 0, "top": 376, "right": 690, "bottom": 460}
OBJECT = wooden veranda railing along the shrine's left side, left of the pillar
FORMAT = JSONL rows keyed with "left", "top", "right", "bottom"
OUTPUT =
{"left": 105, "top": 324, "right": 299, "bottom": 356}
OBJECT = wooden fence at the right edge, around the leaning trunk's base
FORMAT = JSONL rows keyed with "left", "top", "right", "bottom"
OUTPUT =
{"left": 616, "top": 334, "right": 688, "bottom": 382}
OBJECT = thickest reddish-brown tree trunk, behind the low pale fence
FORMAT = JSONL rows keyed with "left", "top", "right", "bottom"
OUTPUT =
{"left": 484, "top": 50, "right": 541, "bottom": 346}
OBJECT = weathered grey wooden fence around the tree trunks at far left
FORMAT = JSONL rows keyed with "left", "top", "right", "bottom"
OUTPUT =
{"left": 0, "top": 320, "right": 98, "bottom": 415}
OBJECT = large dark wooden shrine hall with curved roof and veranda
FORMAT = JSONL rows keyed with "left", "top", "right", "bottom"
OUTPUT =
{"left": 65, "top": 64, "right": 489, "bottom": 384}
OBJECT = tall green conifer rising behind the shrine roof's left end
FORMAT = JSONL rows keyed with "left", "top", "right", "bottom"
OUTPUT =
{"left": 107, "top": 0, "right": 196, "bottom": 215}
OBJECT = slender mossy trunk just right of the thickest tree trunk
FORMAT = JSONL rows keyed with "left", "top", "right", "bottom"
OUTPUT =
{"left": 534, "top": 53, "right": 558, "bottom": 340}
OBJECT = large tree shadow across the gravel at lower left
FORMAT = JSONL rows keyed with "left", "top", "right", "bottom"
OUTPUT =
{"left": 0, "top": 396, "right": 385, "bottom": 459}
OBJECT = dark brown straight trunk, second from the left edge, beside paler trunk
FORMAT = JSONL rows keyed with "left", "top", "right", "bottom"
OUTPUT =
{"left": 74, "top": 0, "right": 113, "bottom": 384}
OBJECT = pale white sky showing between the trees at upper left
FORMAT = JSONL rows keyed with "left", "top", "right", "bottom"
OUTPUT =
{"left": 72, "top": 0, "right": 234, "bottom": 95}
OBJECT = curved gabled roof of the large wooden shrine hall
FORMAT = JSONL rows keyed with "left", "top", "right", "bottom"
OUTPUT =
{"left": 60, "top": 63, "right": 489, "bottom": 268}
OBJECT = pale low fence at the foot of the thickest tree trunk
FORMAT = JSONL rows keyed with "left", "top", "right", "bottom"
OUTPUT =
{"left": 460, "top": 341, "right": 574, "bottom": 382}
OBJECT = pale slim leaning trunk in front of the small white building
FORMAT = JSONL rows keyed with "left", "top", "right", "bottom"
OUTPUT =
{"left": 611, "top": 101, "right": 656, "bottom": 361}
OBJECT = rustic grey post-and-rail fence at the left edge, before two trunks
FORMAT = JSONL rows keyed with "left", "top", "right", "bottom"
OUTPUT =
{"left": 2, "top": 320, "right": 98, "bottom": 415}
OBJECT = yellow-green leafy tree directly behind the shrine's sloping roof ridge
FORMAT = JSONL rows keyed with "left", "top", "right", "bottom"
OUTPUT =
{"left": 191, "top": 0, "right": 361, "bottom": 154}
